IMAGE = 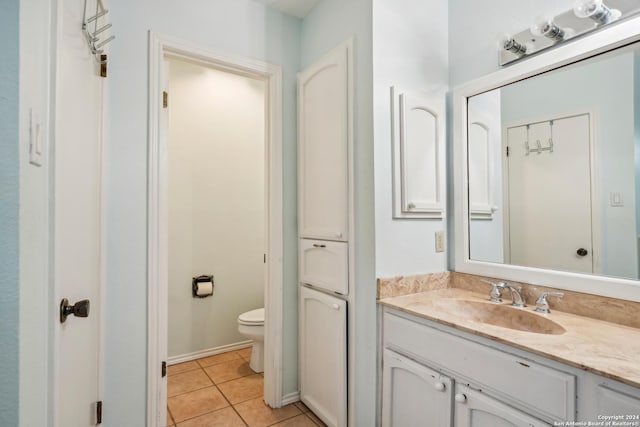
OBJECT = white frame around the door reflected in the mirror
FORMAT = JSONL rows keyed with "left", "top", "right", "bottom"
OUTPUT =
{"left": 501, "top": 108, "right": 602, "bottom": 274}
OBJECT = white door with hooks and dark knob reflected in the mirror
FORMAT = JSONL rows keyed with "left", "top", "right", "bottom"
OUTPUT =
{"left": 507, "top": 114, "right": 594, "bottom": 273}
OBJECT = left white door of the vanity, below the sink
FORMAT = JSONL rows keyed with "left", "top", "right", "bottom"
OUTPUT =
{"left": 382, "top": 349, "right": 453, "bottom": 427}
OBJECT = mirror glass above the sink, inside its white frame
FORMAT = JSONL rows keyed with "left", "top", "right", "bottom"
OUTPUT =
{"left": 467, "top": 43, "right": 640, "bottom": 279}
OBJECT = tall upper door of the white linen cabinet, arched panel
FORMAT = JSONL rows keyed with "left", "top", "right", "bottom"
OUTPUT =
{"left": 298, "top": 44, "right": 351, "bottom": 241}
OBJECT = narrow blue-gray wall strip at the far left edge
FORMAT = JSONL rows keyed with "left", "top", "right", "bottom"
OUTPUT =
{"left": 0, "top": 0, "right": 20, "bottom": 427}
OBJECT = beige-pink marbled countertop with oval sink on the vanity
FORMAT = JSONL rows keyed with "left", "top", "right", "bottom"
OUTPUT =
{"left": 378, "top": 288, "right": 640, "bottom": 387}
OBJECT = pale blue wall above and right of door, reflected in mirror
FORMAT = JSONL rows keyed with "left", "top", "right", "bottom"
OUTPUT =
{"left": 500, "top": 53, "right": 638, "bottom": 278}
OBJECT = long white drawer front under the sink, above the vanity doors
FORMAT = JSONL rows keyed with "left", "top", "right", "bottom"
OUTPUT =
{"left": 383, "top": 311, "right": 576, "bottom": 421}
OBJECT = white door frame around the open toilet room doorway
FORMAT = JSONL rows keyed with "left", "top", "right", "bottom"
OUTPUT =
{"left": 147, "top": 31, "right": 283, "bottom": 426}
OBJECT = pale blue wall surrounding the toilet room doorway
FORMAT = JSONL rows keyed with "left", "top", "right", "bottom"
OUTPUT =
{"left": 104, "top": 0, "right": 300, "bottom": 426}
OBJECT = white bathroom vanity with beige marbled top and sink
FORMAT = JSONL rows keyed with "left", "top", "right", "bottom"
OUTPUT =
{"left": 380, "top": 288, "right": 640, "bottom": 427}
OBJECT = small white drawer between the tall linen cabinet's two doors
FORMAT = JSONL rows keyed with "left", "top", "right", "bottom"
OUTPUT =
{"left": 300, "top": 239, "right": 349, "bottom": 295}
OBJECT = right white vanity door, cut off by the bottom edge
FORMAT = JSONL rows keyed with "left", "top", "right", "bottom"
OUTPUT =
{"left": 453, "top": 384, "right": 550, "bottom": 427}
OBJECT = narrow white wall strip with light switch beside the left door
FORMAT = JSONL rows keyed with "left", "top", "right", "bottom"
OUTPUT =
{"left": 17, "top": 0, "right": 53, "bottom": 426}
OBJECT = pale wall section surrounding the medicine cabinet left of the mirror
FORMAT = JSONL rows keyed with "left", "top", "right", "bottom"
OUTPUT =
{"left": 373, "top": 0, "right": 449, "bottom": 278}
